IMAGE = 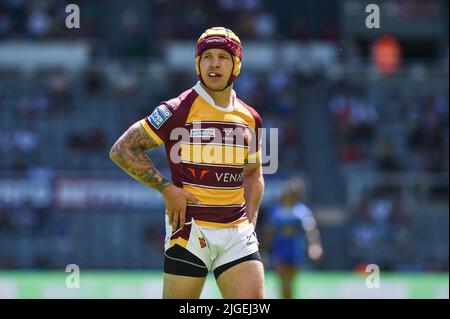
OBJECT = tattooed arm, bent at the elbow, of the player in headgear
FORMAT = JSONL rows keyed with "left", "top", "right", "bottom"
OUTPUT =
{"left": 111, "top": 123, "right": 171, "bottom": 191}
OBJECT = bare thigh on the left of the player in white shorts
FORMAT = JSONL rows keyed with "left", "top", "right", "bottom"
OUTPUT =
{"left": 163, "top": 273, "right": 206, "bottom": 299}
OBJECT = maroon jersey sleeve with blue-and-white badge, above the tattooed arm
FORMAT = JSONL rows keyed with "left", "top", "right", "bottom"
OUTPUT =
{"left": 140, "top": 103, "right": 178, "bottom": 145}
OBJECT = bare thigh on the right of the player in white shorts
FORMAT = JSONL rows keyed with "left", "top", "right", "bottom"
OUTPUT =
{"left": 217, "top": 260, "right": 264, "bottom": 299}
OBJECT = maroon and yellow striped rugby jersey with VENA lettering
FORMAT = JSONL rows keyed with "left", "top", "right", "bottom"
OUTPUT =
{"left": 140, "top": 82, "right": 262, "bottom": 245}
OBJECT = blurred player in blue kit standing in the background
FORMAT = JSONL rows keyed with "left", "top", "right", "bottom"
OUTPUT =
{"left": 265, "top": 178, "right": 323, "bottom": 299}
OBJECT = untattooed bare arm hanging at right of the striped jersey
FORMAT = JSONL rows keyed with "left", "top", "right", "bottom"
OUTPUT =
{"left": 244, "top": 163, "right": 264, "bottom": 226}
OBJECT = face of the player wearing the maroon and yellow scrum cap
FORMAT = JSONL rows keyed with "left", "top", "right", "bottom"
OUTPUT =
{"left": 200, "top": 49, "right": 233, "bottom": 90}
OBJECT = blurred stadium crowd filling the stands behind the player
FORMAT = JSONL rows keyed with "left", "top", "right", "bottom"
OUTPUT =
{"left": 0, "top": 0, "right": 449, "bottom": 271}
